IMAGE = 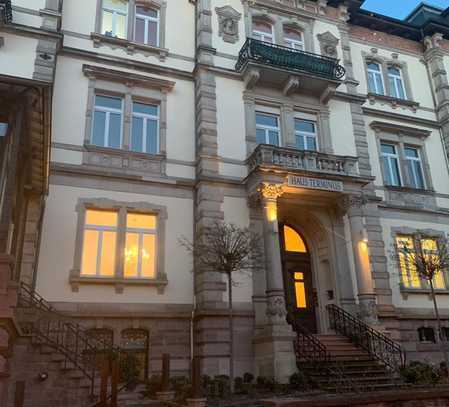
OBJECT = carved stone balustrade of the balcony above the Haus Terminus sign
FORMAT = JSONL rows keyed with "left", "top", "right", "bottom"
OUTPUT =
{"left": 247, "top": 144, "right": 358, "bottom": 176}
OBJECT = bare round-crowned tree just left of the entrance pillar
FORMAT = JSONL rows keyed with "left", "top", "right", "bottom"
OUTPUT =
{"left": 180, "top": 221, "right": 263, "bottom": 390}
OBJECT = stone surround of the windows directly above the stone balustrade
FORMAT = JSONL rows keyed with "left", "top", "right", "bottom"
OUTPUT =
{"left": 243, "top": 91, "right": 333, "bottom": 157}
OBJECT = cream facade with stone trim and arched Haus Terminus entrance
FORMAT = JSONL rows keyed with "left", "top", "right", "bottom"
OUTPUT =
{"left": 0, "top": 0, "right": 449, "bottom": 396}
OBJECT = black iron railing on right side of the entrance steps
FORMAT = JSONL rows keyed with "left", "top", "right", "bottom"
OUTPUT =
{"left": 326, "top": 304, "right": 406, "bottom": 370}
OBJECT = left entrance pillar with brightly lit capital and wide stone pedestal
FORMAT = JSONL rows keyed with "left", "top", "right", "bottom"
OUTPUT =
{"left": 254, "top": 183, "right": 296, "bottom": 383}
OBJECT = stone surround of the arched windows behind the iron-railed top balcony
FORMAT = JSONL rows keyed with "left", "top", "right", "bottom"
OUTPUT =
{"left": 245, "top": 8, "right": 314, "bottom": 52}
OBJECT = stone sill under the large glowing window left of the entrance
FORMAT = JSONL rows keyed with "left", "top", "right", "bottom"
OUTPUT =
{"left": 69, "top": 275, "right": 168, "bottom": 294}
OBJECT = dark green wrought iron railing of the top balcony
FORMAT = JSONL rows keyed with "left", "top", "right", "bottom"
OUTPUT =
{"left": 235, "top": 38, "right": 346, "bottom": 80}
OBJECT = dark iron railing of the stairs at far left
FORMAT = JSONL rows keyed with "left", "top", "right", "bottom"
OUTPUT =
{"left": 18, "top": 282, "right": 121, "bottom": 397}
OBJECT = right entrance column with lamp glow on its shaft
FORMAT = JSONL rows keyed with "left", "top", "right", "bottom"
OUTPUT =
{"left": 347, "top": 197, "right": 378, "bottom": 324}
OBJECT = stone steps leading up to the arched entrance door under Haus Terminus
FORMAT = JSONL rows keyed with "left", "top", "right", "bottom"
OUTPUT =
{"left": 302, "top": 334, "right": 401, "bottom": 392}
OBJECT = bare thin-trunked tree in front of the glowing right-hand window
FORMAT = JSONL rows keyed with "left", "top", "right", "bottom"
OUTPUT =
{"left": 396, "top": 231, "right": 449, "bottom": 371}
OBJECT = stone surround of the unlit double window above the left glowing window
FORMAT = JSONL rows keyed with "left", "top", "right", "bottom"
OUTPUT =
{"left": 83, "top": 65, "right": 175, "bottom": 175}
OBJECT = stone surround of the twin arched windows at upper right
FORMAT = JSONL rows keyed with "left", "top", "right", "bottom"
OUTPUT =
{"left": 362, "top": 48, "right": 419, "bottom": 112}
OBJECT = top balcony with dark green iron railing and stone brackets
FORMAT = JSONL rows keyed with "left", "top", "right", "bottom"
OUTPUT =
{"left": 235, "top": 38, "right": 346, "bottom": 102}
